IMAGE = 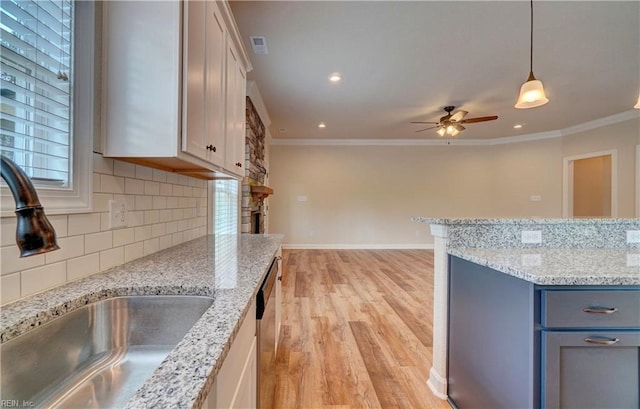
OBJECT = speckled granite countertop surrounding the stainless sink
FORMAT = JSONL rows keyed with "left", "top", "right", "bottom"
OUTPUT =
{"left": 0, "top": 234, "right": 283, "bottom": 408}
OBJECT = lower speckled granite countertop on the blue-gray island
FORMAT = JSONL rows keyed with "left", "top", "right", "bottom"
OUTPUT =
{"left": 447, "top": 247, "right": 640, "bottom": 285}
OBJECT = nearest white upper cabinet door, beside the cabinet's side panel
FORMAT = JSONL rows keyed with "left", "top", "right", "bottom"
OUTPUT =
{"left": 182, "top": 1, "right": 209, "bottom": 160}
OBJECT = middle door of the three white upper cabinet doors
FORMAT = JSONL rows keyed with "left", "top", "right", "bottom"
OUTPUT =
{"left": 205, "top": 1, "right": 227, "bottom": 167}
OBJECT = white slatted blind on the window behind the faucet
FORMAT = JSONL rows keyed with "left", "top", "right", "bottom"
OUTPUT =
{"left": 0, "top": 0, "right": 74, "bottom": 187}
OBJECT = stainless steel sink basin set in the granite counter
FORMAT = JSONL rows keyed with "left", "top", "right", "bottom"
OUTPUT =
{"left": 0, "top": 295, "right": 213, "bottom": 409}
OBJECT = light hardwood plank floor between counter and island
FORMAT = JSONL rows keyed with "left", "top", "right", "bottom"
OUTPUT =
{"left": 273, "top": 250, "right": 450, "bottom": 409}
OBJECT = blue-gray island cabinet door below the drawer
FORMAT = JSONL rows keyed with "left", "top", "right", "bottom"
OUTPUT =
{"left": 542, "top": 331, "right": 640, "bottom": 409}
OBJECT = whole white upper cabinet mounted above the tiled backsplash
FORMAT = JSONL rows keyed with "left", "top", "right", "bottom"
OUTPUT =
{"left": 102, "top": 1, "right": 250, "bottom": 178}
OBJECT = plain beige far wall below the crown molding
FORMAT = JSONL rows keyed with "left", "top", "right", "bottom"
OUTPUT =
{"left": 269, "top": 119, "right": 640, "bottom": 248}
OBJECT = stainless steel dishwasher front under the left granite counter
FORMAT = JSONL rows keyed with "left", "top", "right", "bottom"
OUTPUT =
{"left": 256, "top": 257, "right": 278, "bottom": 409}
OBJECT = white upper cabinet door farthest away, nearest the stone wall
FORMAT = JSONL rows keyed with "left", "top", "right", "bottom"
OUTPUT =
{"left": 225, "top": 40, "right": 247, "bottom": 176}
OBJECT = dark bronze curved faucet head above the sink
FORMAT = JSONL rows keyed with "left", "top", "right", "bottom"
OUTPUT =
{"left": 0, "top": 155, "right": 60, "bottom": 257}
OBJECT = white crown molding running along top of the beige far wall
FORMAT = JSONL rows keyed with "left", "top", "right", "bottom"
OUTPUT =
{"left": 271, "top": 109, "right": 640, "bottom": 146}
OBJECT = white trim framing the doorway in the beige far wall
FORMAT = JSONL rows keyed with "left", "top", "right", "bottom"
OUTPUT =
{"left": 562, "top": 149, "right": 616, "bottom": 218}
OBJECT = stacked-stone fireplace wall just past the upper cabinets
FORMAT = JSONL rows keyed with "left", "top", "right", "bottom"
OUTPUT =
{"left": 241, "top": 97, "right": 267, "bottom": 233}
